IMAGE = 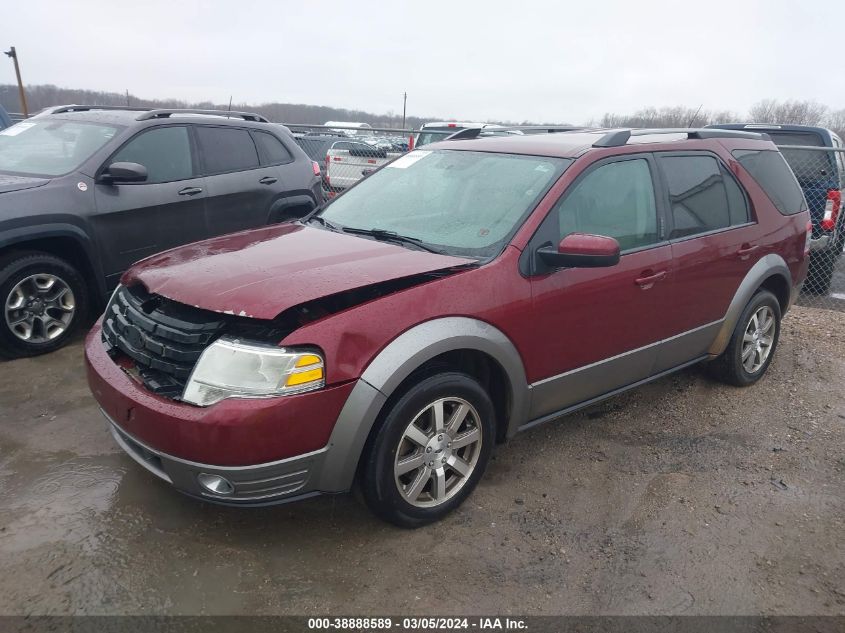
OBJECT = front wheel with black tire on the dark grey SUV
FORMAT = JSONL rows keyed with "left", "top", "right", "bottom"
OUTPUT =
{"left": 0, "top": 251, "right": 88, "bottom": 358}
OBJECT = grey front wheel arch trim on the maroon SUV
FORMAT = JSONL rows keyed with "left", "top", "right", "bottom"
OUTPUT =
{"left": 317, "top": 317, "right": 529, "bottom": 492}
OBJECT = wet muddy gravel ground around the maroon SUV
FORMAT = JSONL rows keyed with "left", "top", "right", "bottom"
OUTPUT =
{"left": 0, "top": 307, "right": 845, "bottom": 615}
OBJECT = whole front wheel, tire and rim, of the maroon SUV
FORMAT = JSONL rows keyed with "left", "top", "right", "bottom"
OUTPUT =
{"left": 361, "top": 372, "right": 496, "bottom": 528}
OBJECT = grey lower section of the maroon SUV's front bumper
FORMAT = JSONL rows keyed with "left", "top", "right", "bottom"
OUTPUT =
{"left": 101, "top": 409, "right": 326, "bottom": 506}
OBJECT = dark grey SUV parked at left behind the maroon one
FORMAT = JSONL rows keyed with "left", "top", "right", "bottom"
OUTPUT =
{"left": 0, "top": 106, "right": 322, "bottom": 358}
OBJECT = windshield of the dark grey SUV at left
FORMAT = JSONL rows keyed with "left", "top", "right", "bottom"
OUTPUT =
{"left": 0, "top": 119, "right": 117, "bottom": 176}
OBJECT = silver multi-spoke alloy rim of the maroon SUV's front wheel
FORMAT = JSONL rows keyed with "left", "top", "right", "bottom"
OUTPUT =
{"left": 393, "top": 397, "right": 482, "bottom": 508}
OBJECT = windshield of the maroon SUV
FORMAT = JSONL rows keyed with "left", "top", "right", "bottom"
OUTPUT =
{"left": 321, "top": 150, "right": 572, "bottom": 259}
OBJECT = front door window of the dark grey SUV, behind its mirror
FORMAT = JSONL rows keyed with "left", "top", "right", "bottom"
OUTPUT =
{"left": 109, "top": 125, "right": 194, "bottom": 184}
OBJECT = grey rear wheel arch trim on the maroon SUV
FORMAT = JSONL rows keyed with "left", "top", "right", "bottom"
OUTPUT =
{"left": 707, "top": 253, "right": 792, "bottom": 358}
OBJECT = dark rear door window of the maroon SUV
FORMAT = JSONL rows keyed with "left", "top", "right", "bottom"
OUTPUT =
{"left": 658, "top": 155, "right": 749, "bottom": 239}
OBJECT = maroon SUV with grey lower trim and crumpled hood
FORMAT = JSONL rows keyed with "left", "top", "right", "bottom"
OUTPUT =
{"left": 86, "top": 130, "right": 809, "bottom": 526}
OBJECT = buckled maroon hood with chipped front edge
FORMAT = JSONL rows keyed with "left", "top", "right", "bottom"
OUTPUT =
{"left": 122, "top": 224, "right": 475, "bottom": 319}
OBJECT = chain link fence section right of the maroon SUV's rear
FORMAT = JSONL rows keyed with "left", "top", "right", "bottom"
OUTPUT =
{"left": 779, "top": 145, "right": 845, "bottom": 311}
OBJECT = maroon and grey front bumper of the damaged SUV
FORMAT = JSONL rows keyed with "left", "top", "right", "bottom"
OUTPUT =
{"left": 85, "top": 323, "right": 356, "bottom": 505}
